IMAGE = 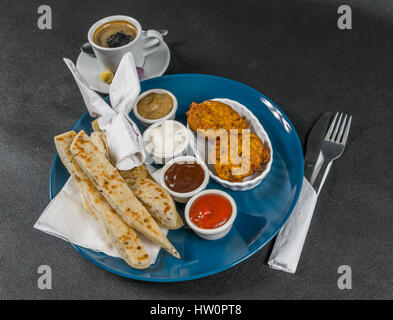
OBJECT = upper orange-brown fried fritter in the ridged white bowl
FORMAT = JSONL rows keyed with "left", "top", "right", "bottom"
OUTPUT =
{"left": 186, "top": 100, "right": 248, "bottom": 137}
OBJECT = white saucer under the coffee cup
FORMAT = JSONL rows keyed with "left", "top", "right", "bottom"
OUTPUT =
{"left": 76, "top": 42, "right": 171, "bottom": 94}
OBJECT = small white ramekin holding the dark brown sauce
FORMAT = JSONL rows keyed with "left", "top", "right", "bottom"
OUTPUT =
{"left": 160, "top": 156, "right": 210, "bottom": 203}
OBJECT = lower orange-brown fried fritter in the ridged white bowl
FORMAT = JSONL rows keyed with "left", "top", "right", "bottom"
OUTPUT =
{"left": 210, "top": 132, "right": 270, "bottom": 182}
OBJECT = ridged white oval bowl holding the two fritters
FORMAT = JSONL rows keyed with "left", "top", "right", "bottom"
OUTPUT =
{"left": 187, "top": 98, "right": 273, "bottom": 191}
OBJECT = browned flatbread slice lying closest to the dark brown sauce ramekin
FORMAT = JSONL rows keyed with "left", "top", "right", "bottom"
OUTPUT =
{"left": 128, "top": 178, "right": 184, "bottom": 229}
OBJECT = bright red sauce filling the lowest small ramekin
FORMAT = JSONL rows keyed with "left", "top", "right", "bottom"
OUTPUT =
{"left": 189, "top": 193, "right": 232, "bottom": 229}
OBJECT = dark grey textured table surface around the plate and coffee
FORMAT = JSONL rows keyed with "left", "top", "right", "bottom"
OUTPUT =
{"left": 0, "top": 0, "right": 393, "bottom": 299}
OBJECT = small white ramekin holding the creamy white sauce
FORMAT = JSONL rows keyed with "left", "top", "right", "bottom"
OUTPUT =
{"left": 143, "top": 120, "right": 190, "bottom": 164}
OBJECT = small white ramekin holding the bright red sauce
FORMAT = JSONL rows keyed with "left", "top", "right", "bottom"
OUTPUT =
{"left": 184, "top": 189, "right": 237, "bottom": 240}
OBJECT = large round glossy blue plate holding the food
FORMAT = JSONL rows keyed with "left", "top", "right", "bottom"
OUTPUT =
{"left": 50, "top": 74, "right": 303, "bottom": 282}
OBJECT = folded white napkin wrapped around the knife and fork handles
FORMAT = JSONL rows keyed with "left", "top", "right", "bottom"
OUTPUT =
{"left": 268, "top": 154, "right": 331, "bottom": 273}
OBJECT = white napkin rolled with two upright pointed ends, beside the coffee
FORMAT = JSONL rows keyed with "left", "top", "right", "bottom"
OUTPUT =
{"left": 64, "top": 53, "right": 146, "bottom": 170}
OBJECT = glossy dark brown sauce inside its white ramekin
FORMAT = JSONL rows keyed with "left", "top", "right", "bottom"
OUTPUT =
{"left": 164, "top": 162, "right": 205, "bottom": 193}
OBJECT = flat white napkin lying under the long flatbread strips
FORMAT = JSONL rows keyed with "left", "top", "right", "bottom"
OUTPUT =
{"left": 34, "top": 178, "right": 168, "bottom": 264}
